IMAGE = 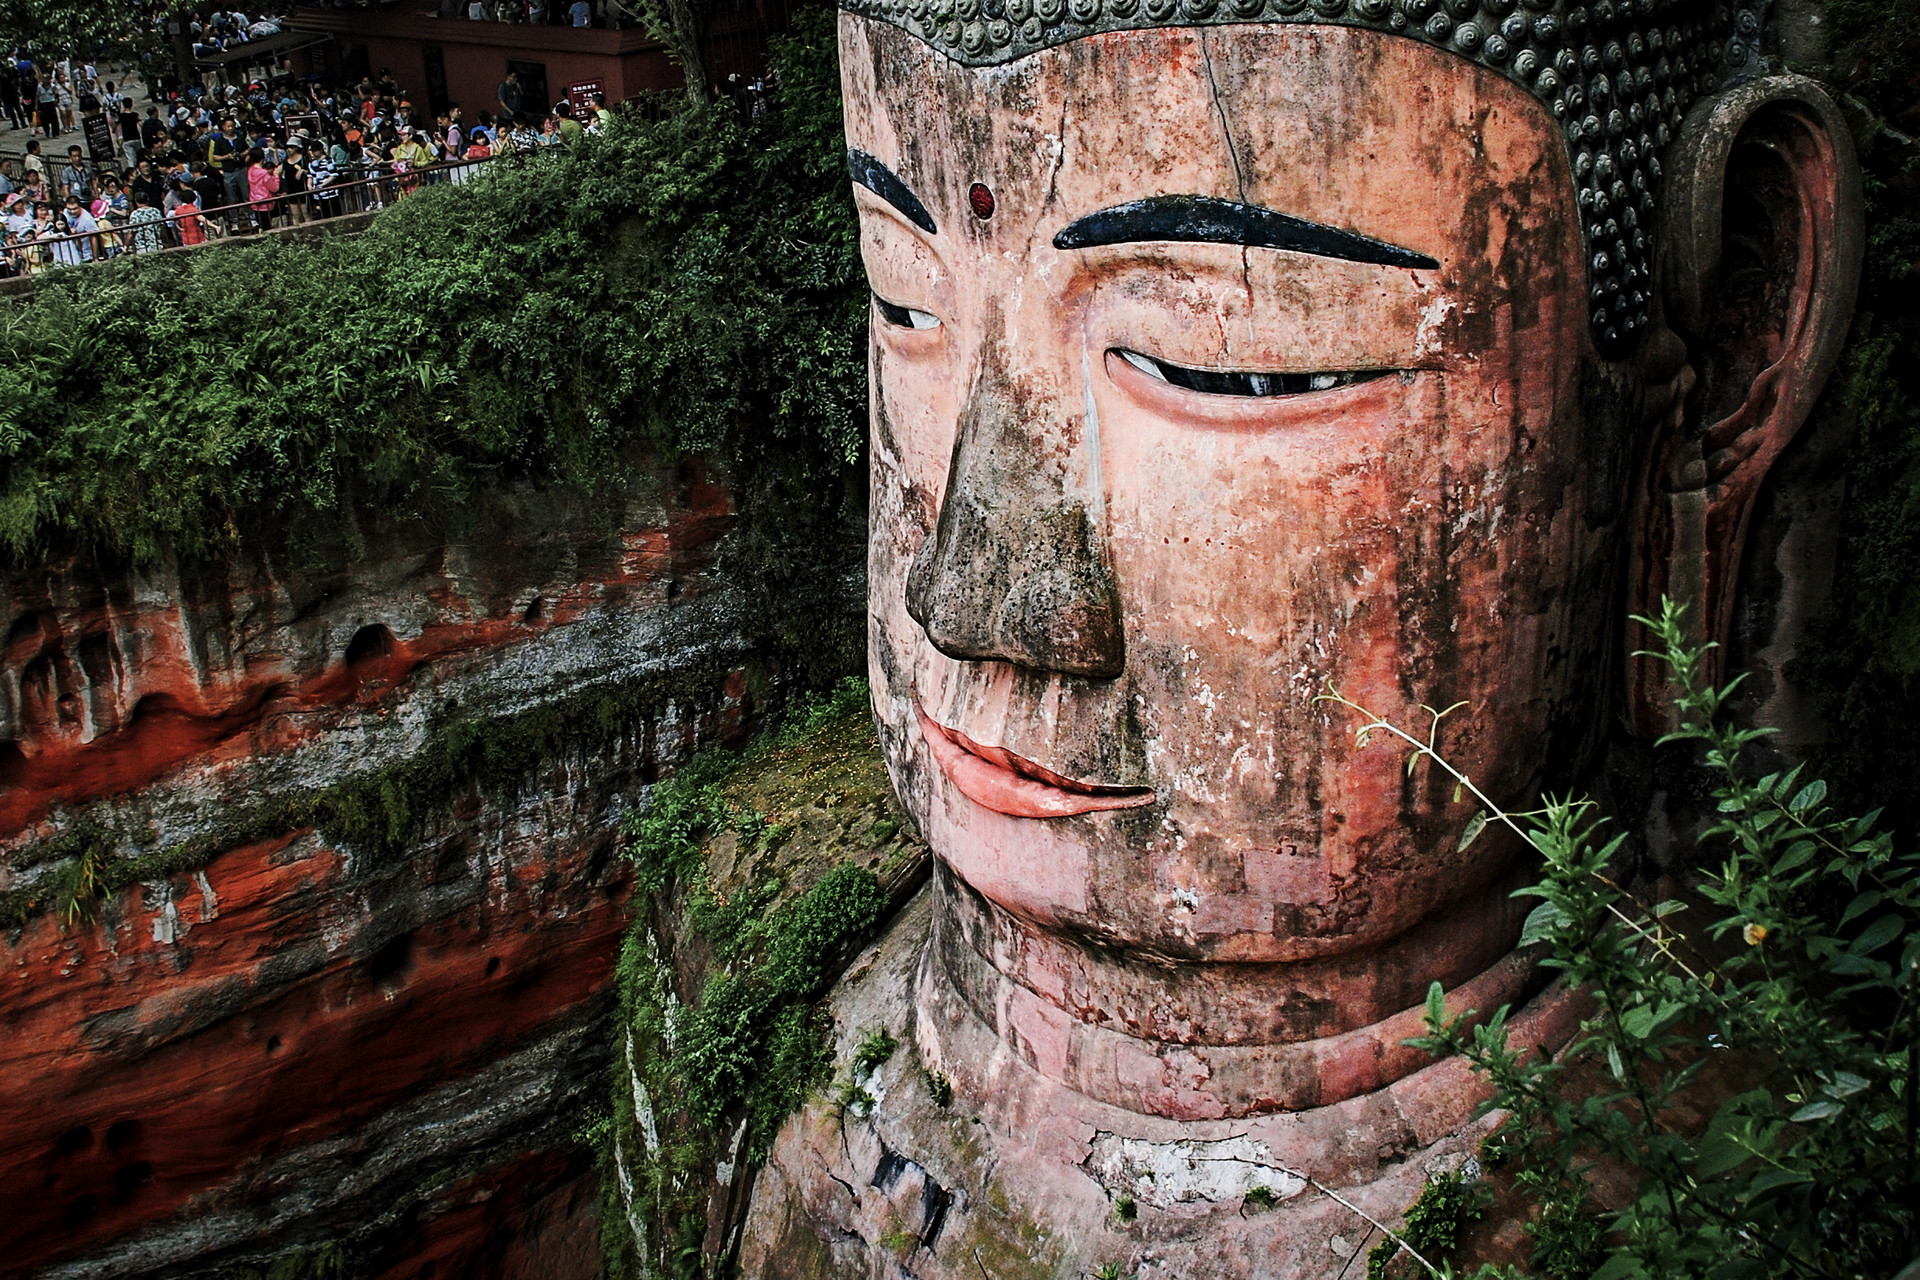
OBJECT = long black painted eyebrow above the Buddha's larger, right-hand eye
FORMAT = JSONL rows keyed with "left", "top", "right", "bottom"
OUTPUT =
{"left": 1052, "top": 195, "right": 1440, "bottom": 269}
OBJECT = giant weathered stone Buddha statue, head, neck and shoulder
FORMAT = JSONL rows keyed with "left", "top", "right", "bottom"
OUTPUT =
{"left": 743, "top": 0, "right": 1860, "bottom": 1280}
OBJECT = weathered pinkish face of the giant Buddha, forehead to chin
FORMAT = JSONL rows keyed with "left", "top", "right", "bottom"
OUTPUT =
{"left": 856, "top": 15, "right": 1659, "bottom": 971}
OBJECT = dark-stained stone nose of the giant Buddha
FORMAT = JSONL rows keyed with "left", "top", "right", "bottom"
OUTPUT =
{"left": 906, "top": 360, "right": 1127, "bottom": 679}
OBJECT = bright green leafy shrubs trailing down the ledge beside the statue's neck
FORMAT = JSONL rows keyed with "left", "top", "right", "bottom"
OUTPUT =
{"left": 603, "top": 694, "right": 887, "bottom": 1274}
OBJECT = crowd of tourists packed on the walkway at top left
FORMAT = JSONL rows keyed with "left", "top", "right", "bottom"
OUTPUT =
{"left": 0, "top": 48, "right": 609, "bottom": 276}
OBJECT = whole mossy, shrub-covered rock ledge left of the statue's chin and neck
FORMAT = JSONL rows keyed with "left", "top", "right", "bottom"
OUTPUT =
{"left": 603, "top": 679, "right": 904, "bottom": 1276}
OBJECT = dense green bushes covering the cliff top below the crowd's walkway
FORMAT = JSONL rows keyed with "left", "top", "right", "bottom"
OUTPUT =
{"left": 0, "top": 12, "right": 866, "bottom": 572}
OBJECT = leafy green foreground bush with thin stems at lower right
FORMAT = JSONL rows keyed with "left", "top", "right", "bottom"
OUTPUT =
{"left": 1350, "top": 603, "right": 1920, "bottom": 1280}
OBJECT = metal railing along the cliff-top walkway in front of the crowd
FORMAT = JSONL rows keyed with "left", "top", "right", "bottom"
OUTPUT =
{"left": 0, "top": 144, "right": 561, "bottom": 278}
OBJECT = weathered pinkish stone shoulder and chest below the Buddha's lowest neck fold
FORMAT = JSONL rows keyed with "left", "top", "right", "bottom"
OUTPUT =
{"left": 741, "top": 889, "right": 1569, "bottom": 1280}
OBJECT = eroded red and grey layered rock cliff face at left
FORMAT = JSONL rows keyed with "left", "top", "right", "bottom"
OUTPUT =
{"left": 0, "top": 466, "right": 856, "bottom": 1278}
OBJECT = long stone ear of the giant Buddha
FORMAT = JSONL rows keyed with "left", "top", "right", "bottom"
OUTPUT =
{"left": 1626, "top": 75, "right": 1864, "bottom": 735}
